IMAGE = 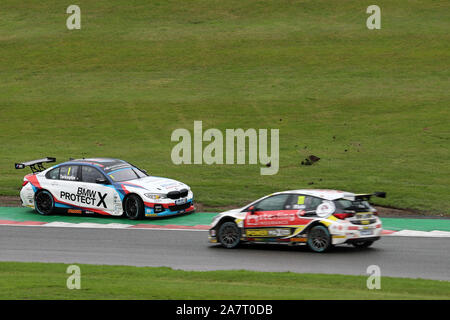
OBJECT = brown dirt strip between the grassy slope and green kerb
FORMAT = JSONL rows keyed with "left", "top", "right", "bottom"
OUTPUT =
{"left": 0, "top": 196, "right": 450, "bottom": 219}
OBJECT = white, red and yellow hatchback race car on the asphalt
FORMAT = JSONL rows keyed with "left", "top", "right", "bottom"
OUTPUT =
{"left": 209, "top": 189, "right": 386, "bottom": 252}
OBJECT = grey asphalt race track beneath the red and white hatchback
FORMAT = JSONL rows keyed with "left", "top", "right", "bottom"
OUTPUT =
{"left": 0, "top": 226, "right": 450, "bottom": 280}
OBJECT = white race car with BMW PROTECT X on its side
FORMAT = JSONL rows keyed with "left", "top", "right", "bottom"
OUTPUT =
{"left": 15, "top": 158, "right": 194, "bottom": 220}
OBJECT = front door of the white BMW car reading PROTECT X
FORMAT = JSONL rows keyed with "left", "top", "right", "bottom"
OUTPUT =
{"left": 77, "top": 165, "right": 118, "bottom": 214}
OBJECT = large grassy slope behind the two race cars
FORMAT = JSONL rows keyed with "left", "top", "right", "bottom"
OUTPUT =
{"left": 0, "top": 0, "right": 450, "bottom": 214}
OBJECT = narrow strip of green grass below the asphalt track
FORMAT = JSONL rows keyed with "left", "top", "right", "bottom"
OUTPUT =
{"left": 0, "top": 262, "right": 450, "bottom": 300}
